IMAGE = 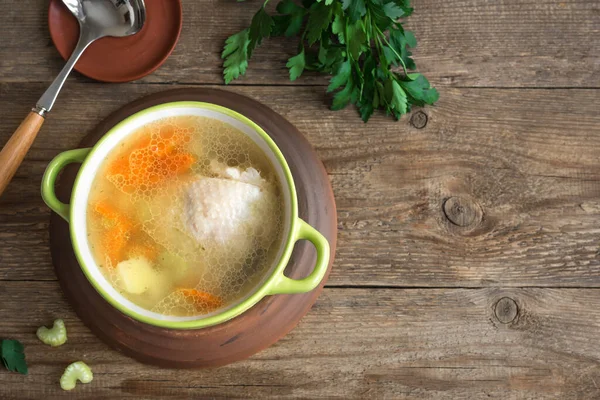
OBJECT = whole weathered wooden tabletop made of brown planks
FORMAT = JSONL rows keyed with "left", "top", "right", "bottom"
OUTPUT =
{"left": 0, "top": 0, "right": 600, "bottom": 399}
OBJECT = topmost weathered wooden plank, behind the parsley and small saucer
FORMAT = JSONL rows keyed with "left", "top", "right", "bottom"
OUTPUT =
{"left": 0, "top": 0, "right": 600, "bottom": 87}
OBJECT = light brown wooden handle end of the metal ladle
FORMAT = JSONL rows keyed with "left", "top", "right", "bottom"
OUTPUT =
{"left": 0, "top": 111, "right": 44, "bottom": 196}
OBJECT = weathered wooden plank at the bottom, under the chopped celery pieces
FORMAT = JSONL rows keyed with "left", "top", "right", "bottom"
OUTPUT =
{"left": 0, "top": 282, "right": 600, "bottom": 400}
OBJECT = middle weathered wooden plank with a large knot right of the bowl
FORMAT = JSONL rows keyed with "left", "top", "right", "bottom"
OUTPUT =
{"left": 0, "top": 84, "right": 600, "bottom": 287}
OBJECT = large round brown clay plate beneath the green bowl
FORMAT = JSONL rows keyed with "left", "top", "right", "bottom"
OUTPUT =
{"left": 50, "top": 88, "right": 337, "bottom": 368}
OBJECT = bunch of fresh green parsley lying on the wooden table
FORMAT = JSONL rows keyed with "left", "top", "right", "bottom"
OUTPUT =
{"left": 221, "top": 0, "right": 439, "bottom": 122}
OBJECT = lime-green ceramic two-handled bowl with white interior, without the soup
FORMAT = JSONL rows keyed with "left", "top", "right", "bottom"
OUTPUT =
{"left": 42, "top": 102, "right": 329, "bottom": 329}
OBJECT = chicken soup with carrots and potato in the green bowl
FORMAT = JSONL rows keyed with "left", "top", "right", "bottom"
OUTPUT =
{"left": 87, "top": 116, "right": 284, "bottom": 316}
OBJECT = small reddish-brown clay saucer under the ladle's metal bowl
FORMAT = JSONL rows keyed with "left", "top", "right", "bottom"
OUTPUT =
{"left": 48, "top": 0, "right": 182, "bottom": 82}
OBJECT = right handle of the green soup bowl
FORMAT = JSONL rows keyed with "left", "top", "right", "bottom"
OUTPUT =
{"left": 268, "top": 218, "right": 329, "bottom": 294}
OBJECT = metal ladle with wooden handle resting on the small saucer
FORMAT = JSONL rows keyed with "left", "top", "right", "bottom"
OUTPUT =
{"left": 0, "top": 0, "right": 146, "bottom": 195}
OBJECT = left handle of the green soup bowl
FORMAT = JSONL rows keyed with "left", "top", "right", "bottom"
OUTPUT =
{"left": 42, "top": 148, "right": 92, "bottom": 222}
